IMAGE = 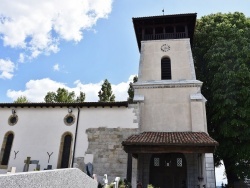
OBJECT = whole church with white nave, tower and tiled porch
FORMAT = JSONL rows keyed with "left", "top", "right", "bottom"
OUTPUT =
{"left": 0, "top": 13, "right": 218, "bottom": 188}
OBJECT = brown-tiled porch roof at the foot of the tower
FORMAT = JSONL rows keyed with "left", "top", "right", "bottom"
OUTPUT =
{"left": 122, "top": 132, "right": 219, "bottom": 154}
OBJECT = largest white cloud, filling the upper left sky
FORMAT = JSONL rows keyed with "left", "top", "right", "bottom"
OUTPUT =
{"left": 0, "top": 0, "right": 112, "bottom": 62}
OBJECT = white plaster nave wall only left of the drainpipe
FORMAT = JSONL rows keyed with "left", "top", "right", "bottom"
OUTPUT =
{"left": 0, "top": 107, "right": 76, "bottom": 172}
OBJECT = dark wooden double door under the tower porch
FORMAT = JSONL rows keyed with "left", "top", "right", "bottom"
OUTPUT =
{"left": 149, "top": 153, "right": 187, "bottom": 188}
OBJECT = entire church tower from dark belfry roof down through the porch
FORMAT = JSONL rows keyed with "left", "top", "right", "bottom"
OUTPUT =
{"left": 123, "top": 13, "right": 218, "bottom": 188}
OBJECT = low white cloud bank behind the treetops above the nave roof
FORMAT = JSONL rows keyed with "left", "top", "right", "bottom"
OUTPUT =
{"left": 7, "top": 75, "right": 134, "bottom": 102}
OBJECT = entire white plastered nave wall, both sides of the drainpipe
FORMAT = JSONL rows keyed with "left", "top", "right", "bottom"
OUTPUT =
{"left": 0, "top": 107, "right": 138, "bottom": 173}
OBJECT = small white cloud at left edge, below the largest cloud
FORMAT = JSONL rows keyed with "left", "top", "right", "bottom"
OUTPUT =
{"left": 0, "top": 59, "right": 15, "bottom": 79}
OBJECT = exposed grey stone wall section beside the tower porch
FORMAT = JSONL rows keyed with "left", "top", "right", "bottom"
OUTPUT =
{"left": 86, "top": 127, "right": 138, "bottom": 182}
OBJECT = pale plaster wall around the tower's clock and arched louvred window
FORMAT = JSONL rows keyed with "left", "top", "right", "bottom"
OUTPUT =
{"left": 138, "top": 39, "right": 196, "bottom": 81}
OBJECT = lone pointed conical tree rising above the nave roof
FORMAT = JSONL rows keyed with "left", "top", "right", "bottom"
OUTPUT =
{"left": 98, "top": 79, "right": 115, "bottom": 102}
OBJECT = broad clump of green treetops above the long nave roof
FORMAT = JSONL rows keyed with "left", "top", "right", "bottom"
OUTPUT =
{"left": 44, "top": 88, "right": 85, "bottom": 103}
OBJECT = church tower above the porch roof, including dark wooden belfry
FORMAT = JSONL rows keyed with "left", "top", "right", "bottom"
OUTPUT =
{"left": 133, "top": 13, "right": 207, "bottom": 132}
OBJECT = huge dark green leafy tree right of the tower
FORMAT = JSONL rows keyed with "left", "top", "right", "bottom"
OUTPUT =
{"left": 193, "top": 12, "right": 250, "bottom": 187}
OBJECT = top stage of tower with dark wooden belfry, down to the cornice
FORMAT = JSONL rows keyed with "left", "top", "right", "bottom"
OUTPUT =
{"left": 133, "top": 13, "right": 196, "bottom": 81}
